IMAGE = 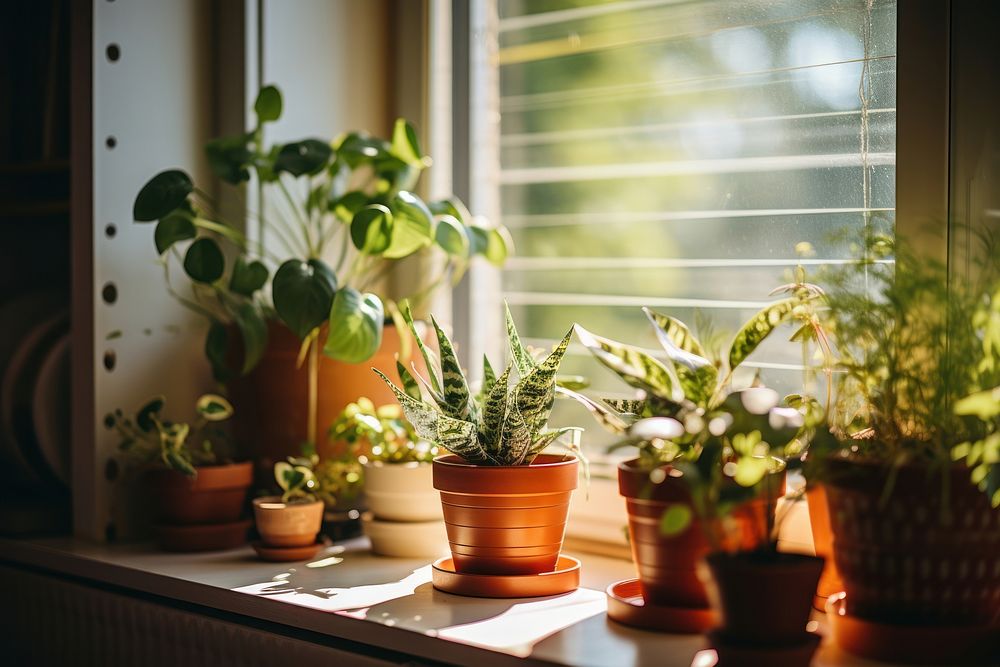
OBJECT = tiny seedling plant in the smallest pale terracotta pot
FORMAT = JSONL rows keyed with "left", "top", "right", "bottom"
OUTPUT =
{"left": 253, "top": 453, "right": 323, "bottom": 560}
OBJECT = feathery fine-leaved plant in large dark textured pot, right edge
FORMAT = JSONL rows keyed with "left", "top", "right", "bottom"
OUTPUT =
{"left": 806, "top": 233, "right": 1000, "bottom": 664}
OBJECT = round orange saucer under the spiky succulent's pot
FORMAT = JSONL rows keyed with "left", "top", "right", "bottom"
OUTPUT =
{"left": 431, "top": 556, "right": 580, "bottom": 598}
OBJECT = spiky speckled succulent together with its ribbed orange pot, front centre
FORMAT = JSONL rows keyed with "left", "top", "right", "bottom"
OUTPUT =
{"left": 375, "top": 310, "right": 579, "bottom": 596}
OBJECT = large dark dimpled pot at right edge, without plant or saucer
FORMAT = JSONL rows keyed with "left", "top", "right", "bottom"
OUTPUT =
{"left": 825, "top": 458, "right": 1000, "bottom": 626}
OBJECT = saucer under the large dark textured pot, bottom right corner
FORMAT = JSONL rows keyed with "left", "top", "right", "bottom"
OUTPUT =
{"left": 826, "top": 593, "right": 1000, "bottom": 665}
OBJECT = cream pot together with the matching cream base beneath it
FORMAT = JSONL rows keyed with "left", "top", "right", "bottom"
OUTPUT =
{"left": 362, "top": 461, "right": 448, "bottom": 558}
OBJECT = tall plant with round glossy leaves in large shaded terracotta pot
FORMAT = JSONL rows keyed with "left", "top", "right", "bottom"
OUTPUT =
{"left": 133, "top": 86, "right": 507, "bottom": 468}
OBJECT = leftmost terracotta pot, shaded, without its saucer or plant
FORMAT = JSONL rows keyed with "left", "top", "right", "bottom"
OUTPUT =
{"left": 149, "top": 462, "right": 253, "bottom": 525}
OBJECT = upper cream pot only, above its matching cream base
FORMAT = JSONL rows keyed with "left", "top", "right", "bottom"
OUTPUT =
{"left": 365, "top": 461, "right": 442, "bottom": 521}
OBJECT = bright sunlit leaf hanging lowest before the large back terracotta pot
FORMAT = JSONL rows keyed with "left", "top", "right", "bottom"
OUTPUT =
{"left": 323, "top": 287, "right": 385, "bottom": 364}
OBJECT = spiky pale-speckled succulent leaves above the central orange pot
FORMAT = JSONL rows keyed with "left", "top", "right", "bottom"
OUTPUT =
{"left": 373, "top": 307, "right": 579, "bottom": 466}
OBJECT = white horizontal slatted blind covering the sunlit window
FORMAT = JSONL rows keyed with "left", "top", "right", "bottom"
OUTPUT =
{"left": 496, "top": 0, "right": 896, "bottom": 452}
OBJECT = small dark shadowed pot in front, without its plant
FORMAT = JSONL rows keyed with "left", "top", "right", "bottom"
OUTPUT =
{"left": 702, "top": 551, "right": 823, "bottom": 646}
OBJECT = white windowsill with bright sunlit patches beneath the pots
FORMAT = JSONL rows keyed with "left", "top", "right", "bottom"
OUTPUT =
{"left": 0, "top": 539, "right": 876, "bottom": 667}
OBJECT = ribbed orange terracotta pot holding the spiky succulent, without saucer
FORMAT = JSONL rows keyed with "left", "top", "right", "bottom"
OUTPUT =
{"left": 434, "top": 454, "right": 578, "bottom": 575}
